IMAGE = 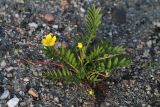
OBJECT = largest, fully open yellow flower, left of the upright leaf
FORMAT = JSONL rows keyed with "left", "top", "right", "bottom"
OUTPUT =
{"left": 42, "top": 33, "right": 56, "bottom": 46}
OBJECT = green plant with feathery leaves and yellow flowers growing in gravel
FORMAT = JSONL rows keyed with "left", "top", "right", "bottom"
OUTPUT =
{"left": 42, "top": 5, "right": 130, "bottom": 85}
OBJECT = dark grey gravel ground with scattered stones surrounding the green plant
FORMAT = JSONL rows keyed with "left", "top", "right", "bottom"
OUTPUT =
{"left": 0, "top": 0, "right": 160, "bottom": 107}
